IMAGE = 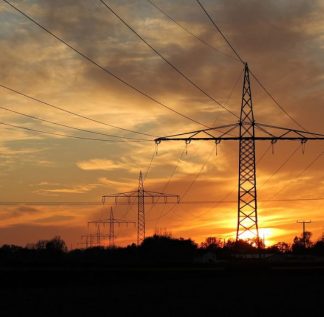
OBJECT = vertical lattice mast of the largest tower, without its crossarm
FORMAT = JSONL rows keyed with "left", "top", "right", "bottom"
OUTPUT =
{"left": 236, "top": 64, "right": 259, "bottom": 240}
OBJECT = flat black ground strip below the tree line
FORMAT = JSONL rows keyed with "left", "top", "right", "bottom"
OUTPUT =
{"left": 0, "top": 263, "right": 324, "bottom": 317}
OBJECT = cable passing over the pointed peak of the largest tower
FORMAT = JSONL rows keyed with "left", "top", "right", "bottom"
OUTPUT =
{"left": 196, "top": 0, "right": 306, "bottom": 131}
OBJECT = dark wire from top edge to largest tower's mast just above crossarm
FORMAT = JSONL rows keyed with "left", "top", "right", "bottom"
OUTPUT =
{"left": 99, "top": 0, "right": 238, "bottom": 118}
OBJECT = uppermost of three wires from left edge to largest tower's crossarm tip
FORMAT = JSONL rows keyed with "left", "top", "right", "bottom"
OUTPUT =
{"left": 0, "top": 84, "right": 154, "bottom": 137}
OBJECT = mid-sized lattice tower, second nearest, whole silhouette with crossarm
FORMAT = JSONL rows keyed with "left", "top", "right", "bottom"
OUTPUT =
{"left": 102, "top": 172, "right": 180, "bottom": 245}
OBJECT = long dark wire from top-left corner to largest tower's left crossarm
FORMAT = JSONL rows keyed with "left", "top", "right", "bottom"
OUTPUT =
{"left": 3, "top": 0, "right": 208, "bottom": 128}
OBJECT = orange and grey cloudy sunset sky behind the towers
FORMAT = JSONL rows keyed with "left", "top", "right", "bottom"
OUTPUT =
{"left": 0, "top": 0, "right": 324, "bottom": 248}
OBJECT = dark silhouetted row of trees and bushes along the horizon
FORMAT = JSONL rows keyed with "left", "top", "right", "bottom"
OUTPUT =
{"left": 0, "top": 232, "right": 324, "bottom": 265}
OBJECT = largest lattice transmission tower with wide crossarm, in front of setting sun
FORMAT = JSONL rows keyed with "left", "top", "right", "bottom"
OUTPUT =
{"left": 155, "top": 63, "right": 324, "bottom": 243}
